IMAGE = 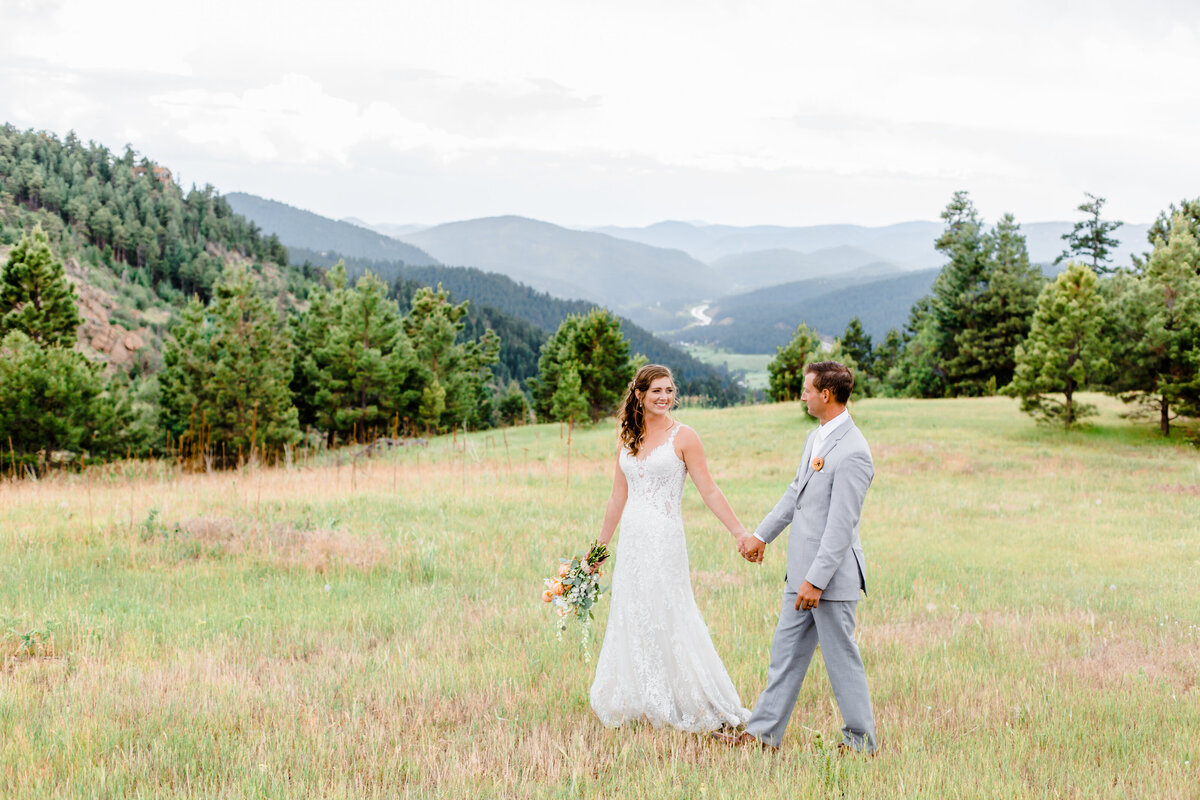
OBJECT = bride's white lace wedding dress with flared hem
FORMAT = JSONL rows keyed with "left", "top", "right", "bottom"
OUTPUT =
{"left": 592, "top": 422, "right": 750, "bottom": 732}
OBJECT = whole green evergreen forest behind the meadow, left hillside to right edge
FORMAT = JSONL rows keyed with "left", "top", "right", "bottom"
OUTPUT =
{"left": 0, "top": 125, "right": 1200, "bottom": 471}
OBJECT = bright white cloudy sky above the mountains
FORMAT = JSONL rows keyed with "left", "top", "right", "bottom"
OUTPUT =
{"left": 0, "top": 0, "right": 1200, "bottom": 225}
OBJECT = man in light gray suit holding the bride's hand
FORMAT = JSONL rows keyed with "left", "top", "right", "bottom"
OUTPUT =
{"left": 726, "top": 361, "right": 877, "bottom": 753}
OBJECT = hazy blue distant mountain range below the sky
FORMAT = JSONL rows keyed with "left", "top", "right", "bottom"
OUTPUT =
{"left": 228, "top": 194, "right": 1148, "bottom": 353}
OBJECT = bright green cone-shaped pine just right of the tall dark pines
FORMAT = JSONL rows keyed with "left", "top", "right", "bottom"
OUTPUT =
{"left": 1004, "top": 261, "right": 1108, "bottom": 428}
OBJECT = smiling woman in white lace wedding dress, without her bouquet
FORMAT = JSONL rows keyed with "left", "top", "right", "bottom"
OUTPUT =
{"left": 592, "top": 363, "right": 752, "bottom": 733}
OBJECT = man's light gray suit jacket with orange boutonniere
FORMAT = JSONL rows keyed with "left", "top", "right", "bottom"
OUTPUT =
{"left": 755, "top": 420, "right": 875, "bottom": 600}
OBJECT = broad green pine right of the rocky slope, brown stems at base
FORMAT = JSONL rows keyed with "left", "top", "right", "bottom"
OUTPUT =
{"left": 160, "top": 265, "right": 300, "bottom": 467}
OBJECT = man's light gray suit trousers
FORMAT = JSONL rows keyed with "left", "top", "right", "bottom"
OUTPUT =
{"left": 746, "top": 591, "right": 877, "bottom": 753}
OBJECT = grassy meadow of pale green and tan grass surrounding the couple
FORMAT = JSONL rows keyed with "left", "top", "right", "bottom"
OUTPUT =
{"left": 0, "top": 398, "right": 1200, "bottom": 800}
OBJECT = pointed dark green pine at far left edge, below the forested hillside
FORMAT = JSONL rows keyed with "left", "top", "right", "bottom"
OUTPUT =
{"left": 0, "top": 225, "right": 80, "bottom": 347}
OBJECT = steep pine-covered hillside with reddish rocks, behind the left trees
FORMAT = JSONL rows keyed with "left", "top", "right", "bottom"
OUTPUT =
{"left": 0, "top": 125, "right": 304, "bottom": 373}
